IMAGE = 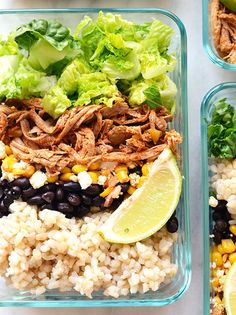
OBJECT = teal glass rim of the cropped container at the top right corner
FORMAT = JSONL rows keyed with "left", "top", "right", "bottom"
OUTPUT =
{"left": 202, "top": 0, "right": 236, "bottom": 71}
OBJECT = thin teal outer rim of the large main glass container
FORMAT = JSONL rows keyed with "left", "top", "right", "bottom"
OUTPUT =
{"left": 0, "top": 8, "right": 192, "bottom": 307}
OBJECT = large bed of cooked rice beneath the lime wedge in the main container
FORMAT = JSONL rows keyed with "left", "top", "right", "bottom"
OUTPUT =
{"left": 0, "top": 201, "right": 177, "bottom": 298}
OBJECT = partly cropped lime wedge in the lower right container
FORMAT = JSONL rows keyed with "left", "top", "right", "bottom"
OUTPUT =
{"left": 224, "top": 263, "right": 236, "bottom": 315}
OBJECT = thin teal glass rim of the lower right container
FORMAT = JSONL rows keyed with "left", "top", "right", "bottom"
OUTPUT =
{"left": 201, "top": 82, "right": 236, "bottom": 315}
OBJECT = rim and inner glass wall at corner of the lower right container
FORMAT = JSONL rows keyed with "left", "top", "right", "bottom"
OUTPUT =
{"left": 201, "top": 83, "right": 236, "bottom": 315}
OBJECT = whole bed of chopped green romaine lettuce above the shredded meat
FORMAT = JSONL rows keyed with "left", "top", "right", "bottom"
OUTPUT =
{"left": 0, "top": 12, "right": 176, "bottom": 118}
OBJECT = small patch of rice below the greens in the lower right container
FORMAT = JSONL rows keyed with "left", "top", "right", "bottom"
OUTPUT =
{"left": 210, "top": 159, "right": 236, "bottom": 219}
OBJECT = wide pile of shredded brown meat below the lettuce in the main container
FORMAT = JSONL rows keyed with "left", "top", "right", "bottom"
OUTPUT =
{"left": 0, "top": 99, "right": 182, "bottom": 175}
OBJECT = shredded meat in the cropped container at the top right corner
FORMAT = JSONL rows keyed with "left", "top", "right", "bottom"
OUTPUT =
{"left": 210, "top": 0, "right": 236, "bottom": 63}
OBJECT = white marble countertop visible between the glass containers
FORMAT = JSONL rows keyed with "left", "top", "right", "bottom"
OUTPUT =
{"left": 0, "top": 0, "right": 235, "bottom": 315}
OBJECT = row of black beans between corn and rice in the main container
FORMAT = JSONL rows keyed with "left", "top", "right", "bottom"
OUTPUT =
{"left": 0, "top": 177, "right": 129, "bottom": 218}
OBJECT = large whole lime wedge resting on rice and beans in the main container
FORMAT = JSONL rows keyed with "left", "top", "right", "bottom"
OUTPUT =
{"left": 98, "top": 149, "right": 182, "bottom": 244}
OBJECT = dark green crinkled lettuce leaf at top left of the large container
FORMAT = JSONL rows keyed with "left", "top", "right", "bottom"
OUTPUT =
{"left": 14, "top": 19, "right": 80, "bottom": 73}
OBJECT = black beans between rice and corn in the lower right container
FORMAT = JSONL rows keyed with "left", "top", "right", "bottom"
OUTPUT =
{"left": 210, "top": 200, "right": 236, "bottom": 244}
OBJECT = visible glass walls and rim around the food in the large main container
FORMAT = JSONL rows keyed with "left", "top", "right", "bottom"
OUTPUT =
{"left": 0, "top": 9, "right": 191, "bottom": 307}
